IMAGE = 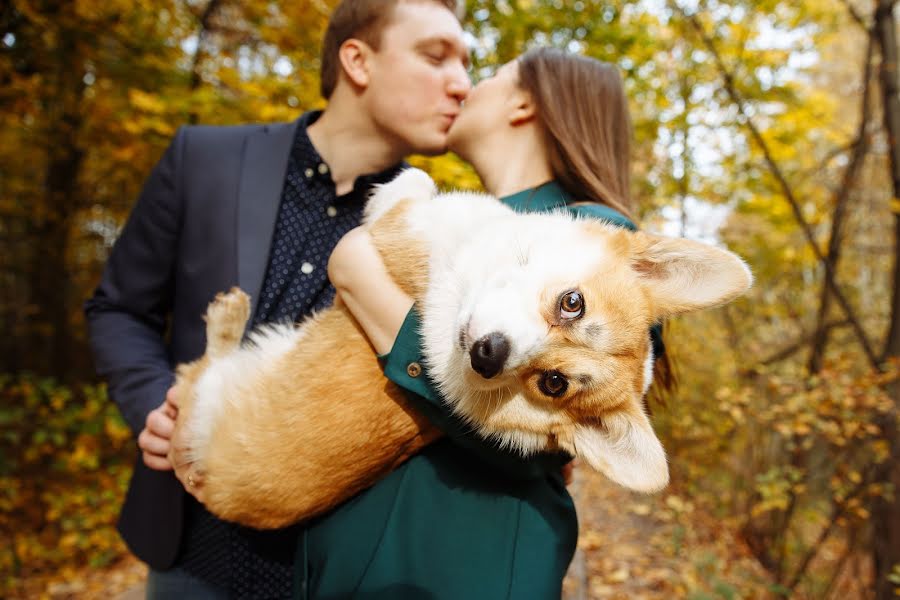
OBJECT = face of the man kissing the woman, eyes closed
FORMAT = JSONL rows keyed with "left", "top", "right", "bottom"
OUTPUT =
{"left": 366, "top": 1, "right": 471, "bottom": 154}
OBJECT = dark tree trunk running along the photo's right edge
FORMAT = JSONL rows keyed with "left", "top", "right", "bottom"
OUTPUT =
{"left": 872, "top": 0, "right": 900, "bottom": 600}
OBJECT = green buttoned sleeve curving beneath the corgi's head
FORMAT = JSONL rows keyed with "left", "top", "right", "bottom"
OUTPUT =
{"left": 379, "top": 307, "right": 571, "bottom": 479}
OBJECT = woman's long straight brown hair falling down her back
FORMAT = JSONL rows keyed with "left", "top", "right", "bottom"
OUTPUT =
{"left": 517, "top": 48, "right": 676, "bottom": 400}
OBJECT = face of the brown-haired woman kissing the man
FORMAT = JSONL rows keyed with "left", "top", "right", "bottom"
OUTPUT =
{"left": 447, "top": 60, "right": 523, "bottom": 158}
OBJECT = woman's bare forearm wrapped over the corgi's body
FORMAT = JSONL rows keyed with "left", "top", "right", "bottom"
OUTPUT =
{"left": 328, "top": 227, "right": 413, "bottom": 354}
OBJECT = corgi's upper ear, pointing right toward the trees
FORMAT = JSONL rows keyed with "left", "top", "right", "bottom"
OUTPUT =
{"left": 631, "top": 232, "right": 753, "bottom": 318}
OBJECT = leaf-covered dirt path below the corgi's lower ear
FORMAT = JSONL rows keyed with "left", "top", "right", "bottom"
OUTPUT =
{"left": 564, "top": 467, "right": 768, "bottom": 600}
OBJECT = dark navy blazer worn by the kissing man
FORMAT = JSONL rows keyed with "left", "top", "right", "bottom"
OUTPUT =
{"left": 85, "top": 116, "right": 306, "bottom": 569}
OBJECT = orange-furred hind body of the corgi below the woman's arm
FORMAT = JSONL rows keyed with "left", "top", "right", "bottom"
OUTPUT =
{"left": 196, "top": 308, "right": 440, "bottom": 528}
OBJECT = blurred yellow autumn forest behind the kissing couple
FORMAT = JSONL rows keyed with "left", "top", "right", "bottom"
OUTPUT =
{"left": 0, "top": 0, "right": 900, "bottom": 600}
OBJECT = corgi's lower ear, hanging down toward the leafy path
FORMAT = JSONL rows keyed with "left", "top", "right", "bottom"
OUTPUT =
{"left": 574, "top": 408, "right": 669, "bottom": 492}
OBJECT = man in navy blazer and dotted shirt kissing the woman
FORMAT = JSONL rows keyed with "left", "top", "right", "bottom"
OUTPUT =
{"left": 85, "top": 0, "right": 470, "bottom": 598}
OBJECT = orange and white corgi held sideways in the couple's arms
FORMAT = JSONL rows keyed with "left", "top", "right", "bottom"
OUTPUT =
{"left": 170, "top": 169, "right": 752, "bottom": 528}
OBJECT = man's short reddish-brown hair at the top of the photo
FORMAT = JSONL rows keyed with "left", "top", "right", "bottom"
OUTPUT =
{"left": 320, "top": 0, "right": 459, "bottom": 99}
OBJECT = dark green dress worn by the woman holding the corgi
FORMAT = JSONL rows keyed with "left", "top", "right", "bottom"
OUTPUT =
{"left": 294, "top": 182, "right": 634, "bottom": 600}
